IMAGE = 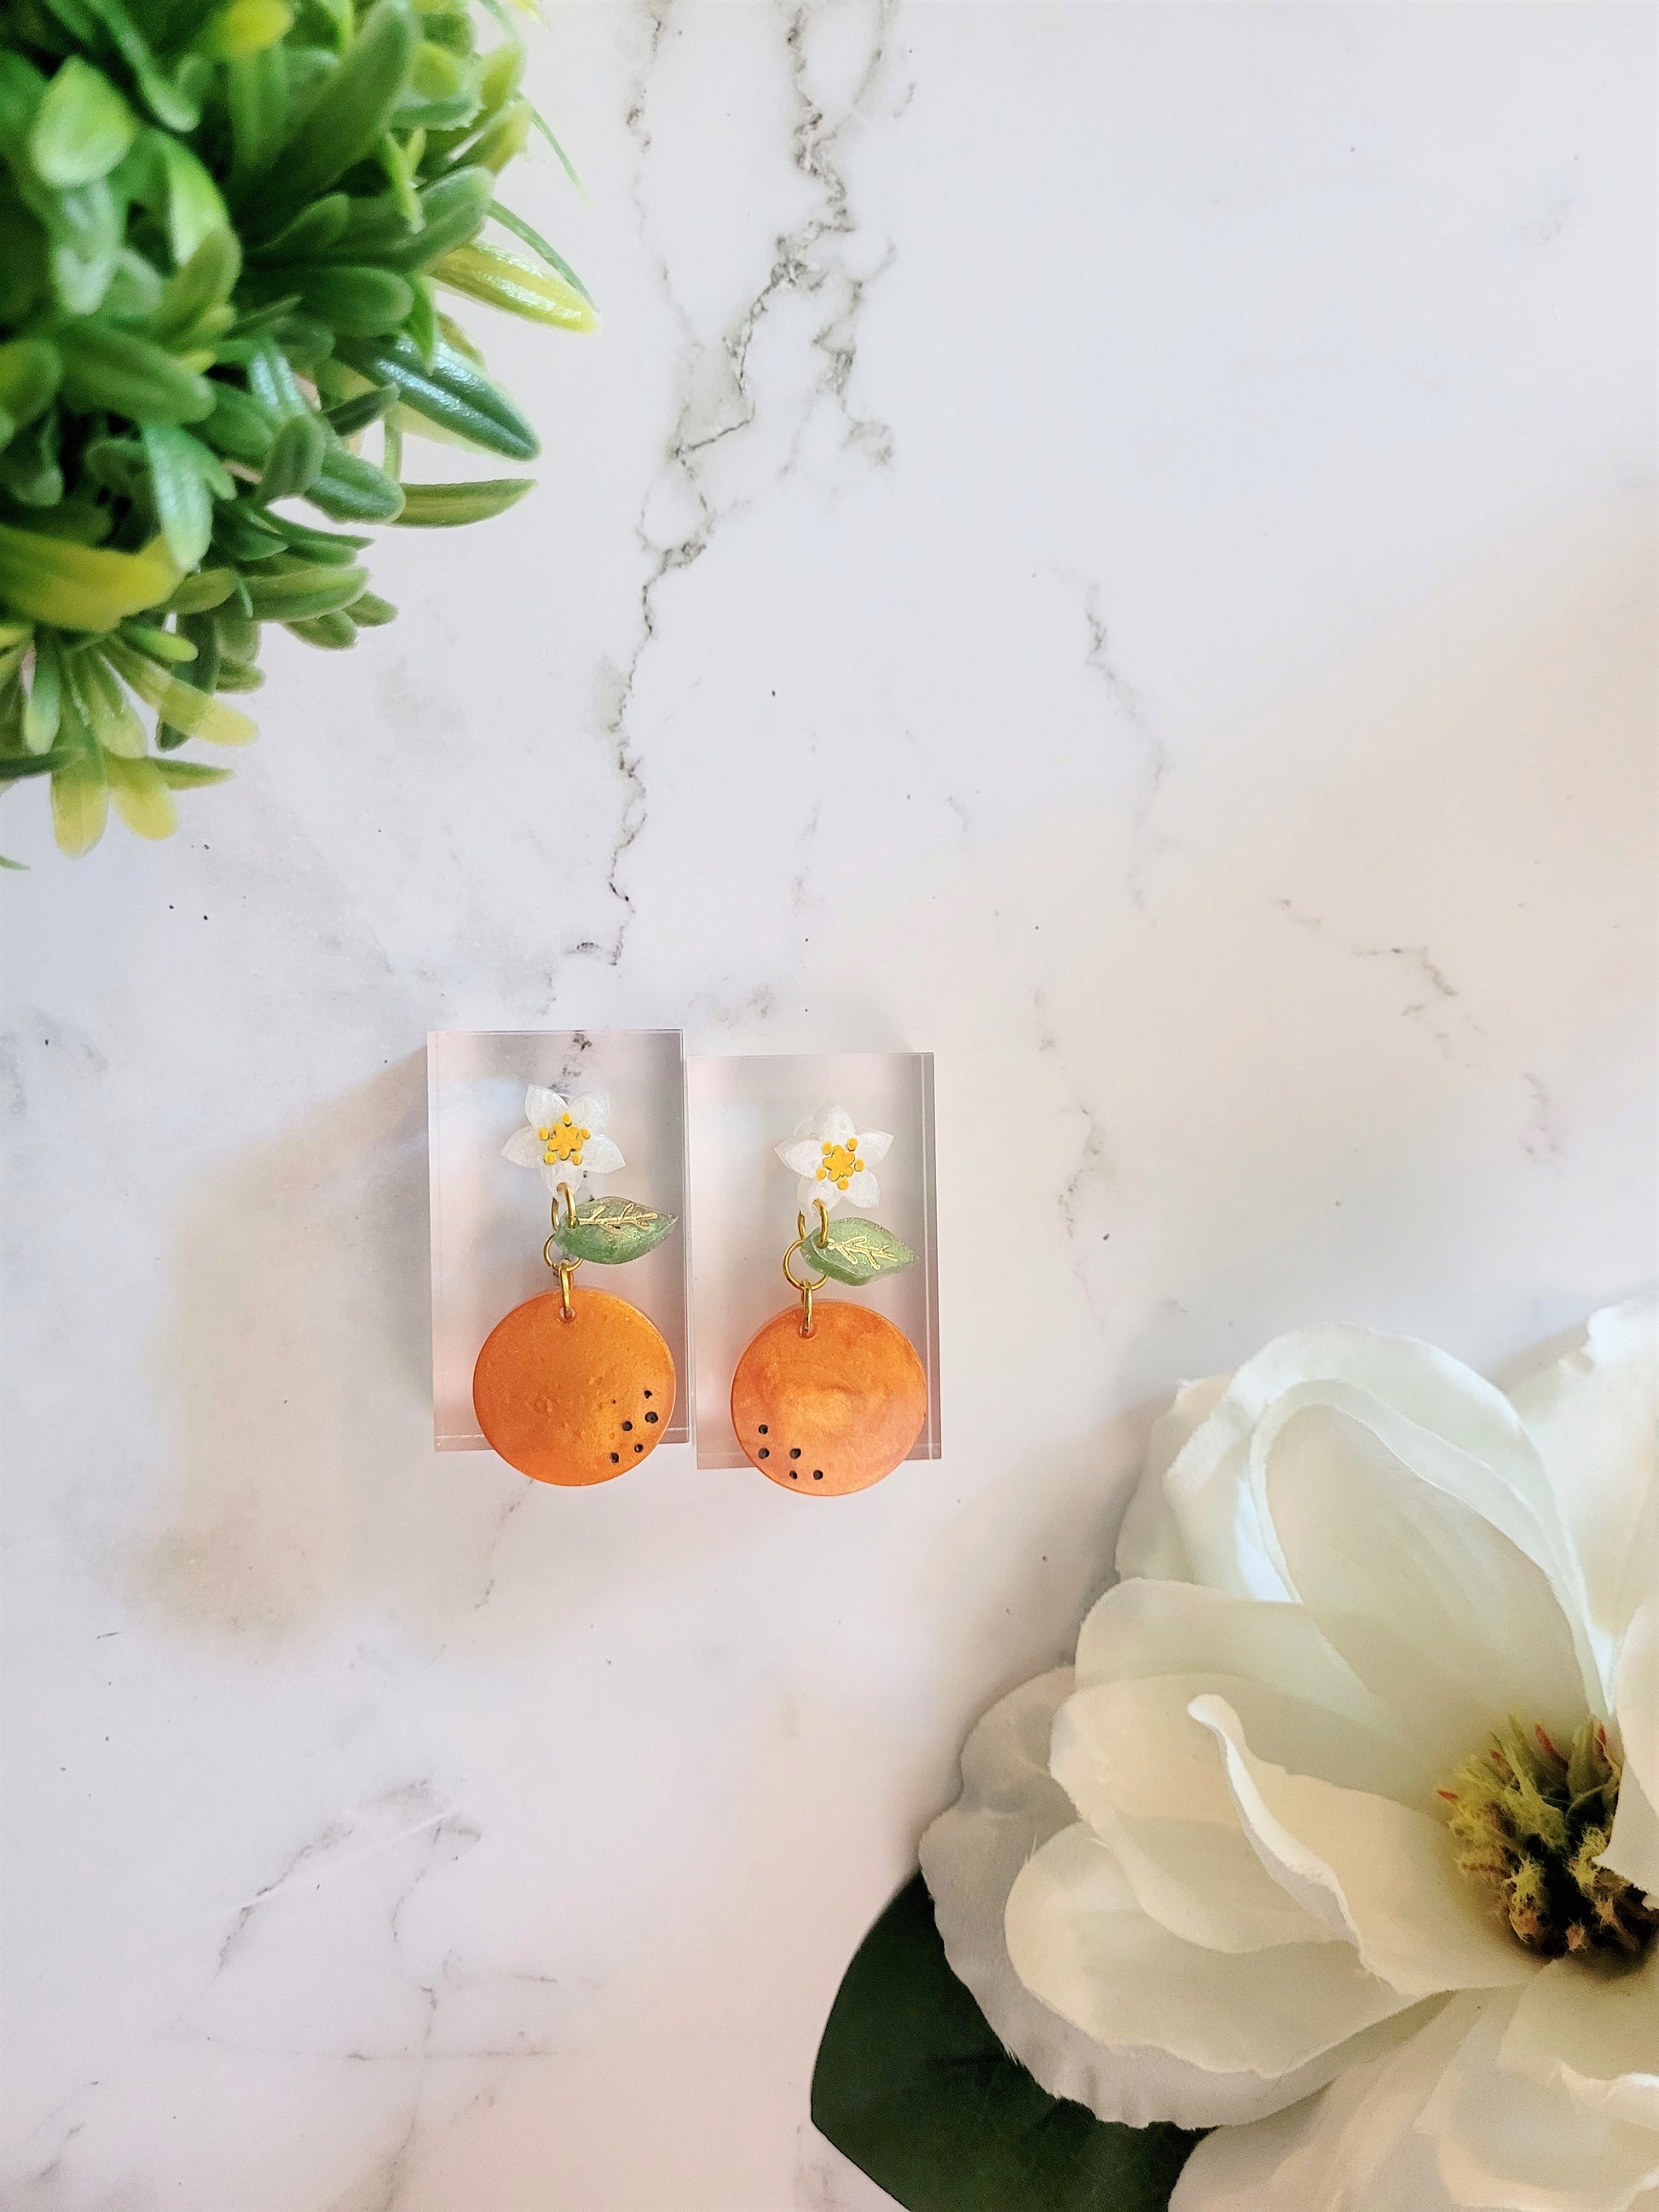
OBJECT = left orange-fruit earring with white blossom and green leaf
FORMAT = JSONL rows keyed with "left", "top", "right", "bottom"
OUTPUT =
{"left": 473, "top": 1084, "right": 677, "bottom": 1487}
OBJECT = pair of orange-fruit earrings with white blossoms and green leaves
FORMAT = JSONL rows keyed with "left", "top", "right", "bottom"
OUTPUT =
{"left": 473, "top": 1084, "right": 927, "bottom": 1498}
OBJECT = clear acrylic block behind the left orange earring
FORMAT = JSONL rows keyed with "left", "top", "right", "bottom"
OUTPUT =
{"left": 427, "top": 1029, "right": 692, "bottom": 1451}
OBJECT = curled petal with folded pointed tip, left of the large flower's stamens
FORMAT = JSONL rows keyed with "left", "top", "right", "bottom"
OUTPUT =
{"left": 1193, "top": 1696, "right": 1537, "bottom": 1997}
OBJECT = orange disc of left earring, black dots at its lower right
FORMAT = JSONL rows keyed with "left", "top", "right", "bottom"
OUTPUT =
{"left": 473, "top": 1290, "right": 674, "bottom": 1487}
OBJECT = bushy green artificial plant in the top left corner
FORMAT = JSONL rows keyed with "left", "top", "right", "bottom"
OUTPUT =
{"left": 0, "top": 0, "right": 598, "bottom": 854}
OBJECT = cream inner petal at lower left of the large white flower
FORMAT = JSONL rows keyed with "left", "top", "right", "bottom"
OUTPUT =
{"left": 1004, "top": 1825, "right": 1411, "bottom": 2097}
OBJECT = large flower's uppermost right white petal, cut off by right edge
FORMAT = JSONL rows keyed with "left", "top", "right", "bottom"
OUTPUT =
{"left": 1511, "top": 1298, "right": 1659, "bottom": 1650}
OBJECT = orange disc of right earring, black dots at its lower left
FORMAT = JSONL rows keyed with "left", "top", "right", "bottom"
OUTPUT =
{"left": 732, "top": 1298, "right": 927, "bottom": 1498}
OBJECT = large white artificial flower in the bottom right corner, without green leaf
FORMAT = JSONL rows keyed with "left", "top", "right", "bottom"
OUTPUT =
{"left": 922, "top": 1302, "right": 1659, "bottom": 2212}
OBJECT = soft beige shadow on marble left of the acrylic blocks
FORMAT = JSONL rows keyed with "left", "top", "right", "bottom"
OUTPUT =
{"left": 137, "top": 1053, "right": 469, "bottom": 1635}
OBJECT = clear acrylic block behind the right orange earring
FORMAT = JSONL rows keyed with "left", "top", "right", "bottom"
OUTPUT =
{"left": 685, "top": 1053, "right": 940, "bottom": 1466}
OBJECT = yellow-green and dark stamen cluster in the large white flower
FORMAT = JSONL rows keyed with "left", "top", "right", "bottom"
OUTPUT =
{"left": 1438, "top": 1721, "right": 1659, "bottom": 1958}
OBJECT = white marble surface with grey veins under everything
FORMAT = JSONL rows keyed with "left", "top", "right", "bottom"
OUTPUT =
{"left": 0, "top": 0, "right": 1655, "bottom": 2212}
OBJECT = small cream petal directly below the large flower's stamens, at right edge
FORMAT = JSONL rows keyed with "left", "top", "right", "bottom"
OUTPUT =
{"left": 1498, "top": 1949, "right": 1659, "bottom": 2128}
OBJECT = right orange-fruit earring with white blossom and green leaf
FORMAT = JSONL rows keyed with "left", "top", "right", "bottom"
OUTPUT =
{"left": 732, "top": 1106, "right": 927, "bottom": 1498}
